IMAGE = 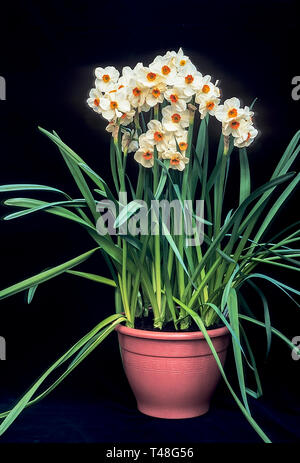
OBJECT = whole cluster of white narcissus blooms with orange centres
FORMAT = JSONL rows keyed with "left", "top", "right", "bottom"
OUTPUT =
{"left": 87, "top": 48, "right": 258, "bottom": 171}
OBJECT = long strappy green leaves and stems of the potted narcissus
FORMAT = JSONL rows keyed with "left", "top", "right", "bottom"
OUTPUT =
{"left": 0, "top": 111, "right": 300, "bottom": 442}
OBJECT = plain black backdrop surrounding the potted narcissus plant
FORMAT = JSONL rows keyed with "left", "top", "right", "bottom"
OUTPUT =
{"left": 0, "top": 1, "right": 300, "bottom": 448}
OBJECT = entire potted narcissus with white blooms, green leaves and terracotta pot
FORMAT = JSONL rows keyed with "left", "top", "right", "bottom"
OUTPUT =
{"left": 0, "top": 49, "right": 300, "bottom": 442}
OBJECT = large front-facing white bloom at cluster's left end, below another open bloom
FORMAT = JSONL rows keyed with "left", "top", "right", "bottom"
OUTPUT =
{"left": 100, "top": 89, "right": 131, "bottom": 121}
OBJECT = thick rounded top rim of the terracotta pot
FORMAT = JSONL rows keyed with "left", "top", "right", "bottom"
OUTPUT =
{"left": 115, "top": 324, "right": 229, "bottom": 341}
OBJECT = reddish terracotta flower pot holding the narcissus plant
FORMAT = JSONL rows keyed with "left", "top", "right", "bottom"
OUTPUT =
{"left": 116, "top": 325, "right": 230, "bottom": 418}
